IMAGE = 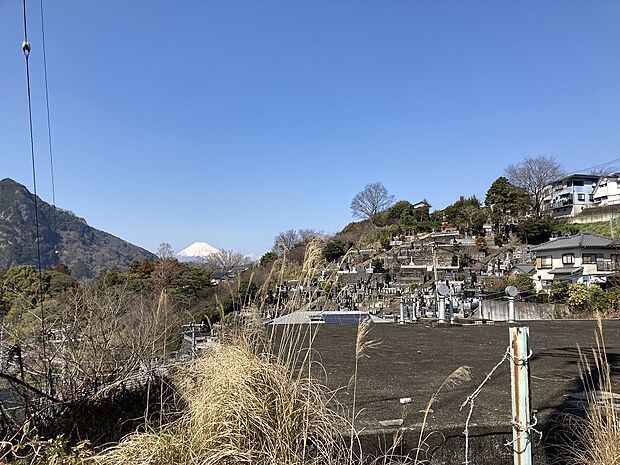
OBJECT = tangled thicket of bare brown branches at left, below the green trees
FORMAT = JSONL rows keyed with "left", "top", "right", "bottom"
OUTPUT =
{"left": 0, "top": 282, "right": 190, "bottom": 401}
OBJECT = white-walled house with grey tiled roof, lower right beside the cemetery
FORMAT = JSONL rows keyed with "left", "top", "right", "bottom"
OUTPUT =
{"left": 531, "top": 233, "right": 620, "bottom": 291}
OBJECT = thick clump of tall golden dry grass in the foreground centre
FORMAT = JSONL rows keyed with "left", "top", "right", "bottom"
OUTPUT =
{"left": 93, "top": 339, "right": 346, "bottom": 465}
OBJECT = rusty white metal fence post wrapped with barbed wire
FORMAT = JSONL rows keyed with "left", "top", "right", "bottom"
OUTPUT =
{"left": 509, "top": 326, "right": 532, "bottom": 465}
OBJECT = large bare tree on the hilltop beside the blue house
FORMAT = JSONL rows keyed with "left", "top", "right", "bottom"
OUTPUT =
{"left": 504, "top": 155, "right": 564, "bottom": 216}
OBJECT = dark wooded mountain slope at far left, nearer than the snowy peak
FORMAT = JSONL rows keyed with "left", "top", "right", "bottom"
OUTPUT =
{"left": 0, "top": 178, "right": 157, "bottom": 279}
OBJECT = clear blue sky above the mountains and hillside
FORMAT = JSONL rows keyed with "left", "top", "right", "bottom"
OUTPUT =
{"left": 0, "top": 0, "right": 620, "bottom": 254}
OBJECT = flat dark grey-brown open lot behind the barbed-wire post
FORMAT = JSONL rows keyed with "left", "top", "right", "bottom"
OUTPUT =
{"left": 290, "top": 320, "right": 620, "bottom": 432}
